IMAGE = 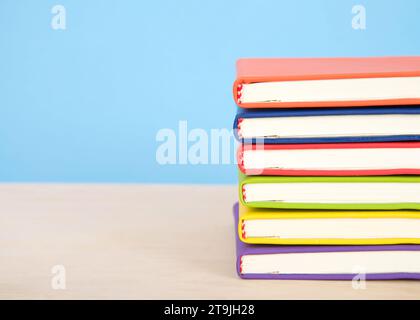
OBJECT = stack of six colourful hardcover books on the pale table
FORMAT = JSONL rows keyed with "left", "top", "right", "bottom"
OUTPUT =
{"left": 233, "top": 57, "right": 420, "bottom": 280}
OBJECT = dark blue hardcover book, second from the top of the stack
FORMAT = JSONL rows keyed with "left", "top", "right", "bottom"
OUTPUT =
{"left": 233, "top": 106, "right": 420, "bottom": 144}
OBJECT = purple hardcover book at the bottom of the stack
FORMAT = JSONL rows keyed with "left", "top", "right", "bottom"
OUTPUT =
{"left": 233, "top": 203, "right": 420, "bottom": 280}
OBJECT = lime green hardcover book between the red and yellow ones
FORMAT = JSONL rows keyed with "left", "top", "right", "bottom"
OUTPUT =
{"left": 239, "top": 173, "right": 420, "bottom": 210}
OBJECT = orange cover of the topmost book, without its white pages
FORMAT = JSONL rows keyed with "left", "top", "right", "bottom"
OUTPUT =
{"left": 233, "top": 56, "right": 420, "bottom": 108}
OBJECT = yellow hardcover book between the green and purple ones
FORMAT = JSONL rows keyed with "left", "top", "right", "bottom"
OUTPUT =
{"left": 238, "top": 204, "right": 420, "bottom": 245}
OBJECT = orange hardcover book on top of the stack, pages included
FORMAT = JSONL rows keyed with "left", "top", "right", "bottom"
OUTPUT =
{"left": 233, "top": 56, "right": 420, "bottom": 108}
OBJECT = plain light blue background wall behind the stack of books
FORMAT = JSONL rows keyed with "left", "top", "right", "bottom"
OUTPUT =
{"left": 0, "top": 0, "right": 420, "bottom": 183}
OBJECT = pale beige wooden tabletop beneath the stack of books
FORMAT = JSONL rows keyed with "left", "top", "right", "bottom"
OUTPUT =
{"left": 0, "top": 184, "right": 420, "bottom": 299}
